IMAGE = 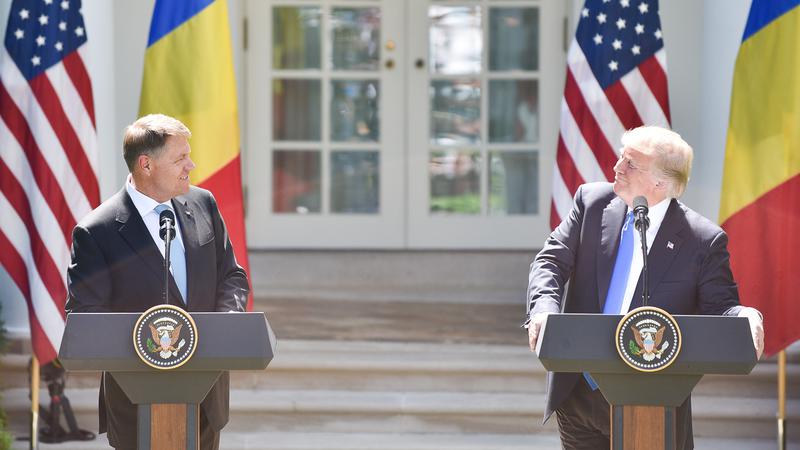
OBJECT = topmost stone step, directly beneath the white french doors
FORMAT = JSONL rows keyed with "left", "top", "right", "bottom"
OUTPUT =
{"left": 250, "top": 250, "right": 535, "bottom": 308}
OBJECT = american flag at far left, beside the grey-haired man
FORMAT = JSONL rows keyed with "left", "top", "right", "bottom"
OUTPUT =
{"left": 0, "top": 0, "right": 100, "bottom": 364}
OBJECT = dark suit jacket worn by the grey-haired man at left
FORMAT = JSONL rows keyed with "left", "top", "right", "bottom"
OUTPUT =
{"left": 65, "top": 186, "right": 250, "bottom": 446}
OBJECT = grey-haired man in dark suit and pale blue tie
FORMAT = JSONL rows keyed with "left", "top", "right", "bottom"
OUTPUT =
{"left": 65, "top": 114, "right": 249, "bottom": 449}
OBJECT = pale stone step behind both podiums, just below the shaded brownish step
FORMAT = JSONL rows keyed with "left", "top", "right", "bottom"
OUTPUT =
{"left": 0, "top": 340, "right": 800, "bottom": 398}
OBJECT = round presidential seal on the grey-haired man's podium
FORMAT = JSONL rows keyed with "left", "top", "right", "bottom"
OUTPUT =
{"left": 133, "top": 305, "right": 197, "bottom": 370}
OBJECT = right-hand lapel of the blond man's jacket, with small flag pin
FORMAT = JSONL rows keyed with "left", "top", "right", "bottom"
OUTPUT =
{"left": 630, "top": 199, "right": 686, "bottom": 309}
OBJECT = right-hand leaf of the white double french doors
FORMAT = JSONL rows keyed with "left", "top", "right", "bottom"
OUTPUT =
{"left": 408, "top": 0, "right": 564, "bottom": 248}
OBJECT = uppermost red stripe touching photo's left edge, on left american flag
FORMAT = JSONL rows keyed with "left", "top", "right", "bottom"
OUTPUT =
{"left": 0, "top": 82, "right": 77, "bottom": 242}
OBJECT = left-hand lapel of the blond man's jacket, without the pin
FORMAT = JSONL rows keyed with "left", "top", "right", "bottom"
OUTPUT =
{"left": 597, "top": 197, "right": 628, "bottom": 311}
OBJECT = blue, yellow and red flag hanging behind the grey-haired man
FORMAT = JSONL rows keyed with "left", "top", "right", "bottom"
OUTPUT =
{"left": 139, "top": 0, "right": 253, "bottom": 310}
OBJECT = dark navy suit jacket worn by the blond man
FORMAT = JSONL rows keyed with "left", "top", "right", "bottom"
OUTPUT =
{"left": 528, "top": 183, "right": 741, "bottom": 444}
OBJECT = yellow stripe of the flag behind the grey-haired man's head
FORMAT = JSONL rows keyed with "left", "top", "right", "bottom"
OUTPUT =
{"left": 139, "top": 0, "right": 239, "bottom": 184}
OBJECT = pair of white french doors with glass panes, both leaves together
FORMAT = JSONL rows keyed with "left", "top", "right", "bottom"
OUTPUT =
{"left": 245, "top": 0, "right": 565, "bottom": 248}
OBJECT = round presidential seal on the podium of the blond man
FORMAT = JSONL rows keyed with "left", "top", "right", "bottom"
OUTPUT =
{"left": 614, "top": 306, "right": 681, "bottom": 372}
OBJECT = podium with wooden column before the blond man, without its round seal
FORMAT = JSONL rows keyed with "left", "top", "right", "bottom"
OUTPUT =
{"left": 536, "top": 314, "right": 757, "bottom": 450}
